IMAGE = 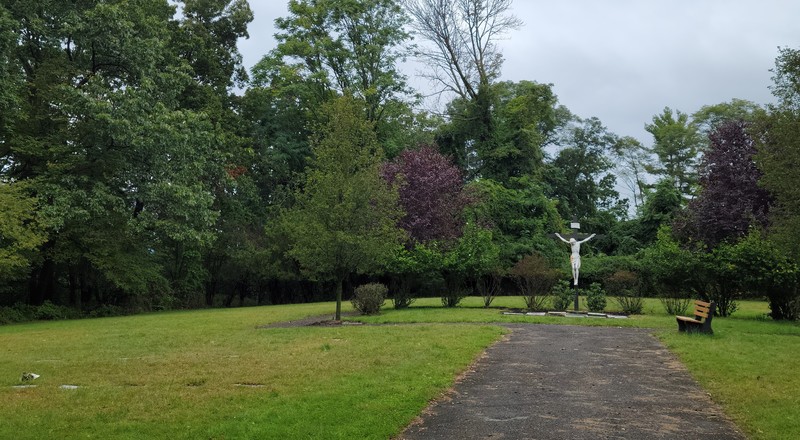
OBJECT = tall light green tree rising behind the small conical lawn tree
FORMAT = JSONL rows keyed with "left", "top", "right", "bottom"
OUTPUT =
{"left": 243, "top": 0, "right": 412, "bottom": 205}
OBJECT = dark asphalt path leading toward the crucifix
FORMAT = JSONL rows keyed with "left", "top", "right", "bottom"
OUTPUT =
{"left": 399, "top": 325, "right": 745, "bottom": 440}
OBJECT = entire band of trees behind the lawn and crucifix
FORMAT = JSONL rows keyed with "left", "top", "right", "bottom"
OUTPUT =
{"left": 0, "top": 0, "right": 800, "bottom": 319}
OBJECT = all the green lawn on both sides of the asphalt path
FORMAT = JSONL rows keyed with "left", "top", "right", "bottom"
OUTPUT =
{"left": 0, "top": 297, "right": 800, "bottom": 439}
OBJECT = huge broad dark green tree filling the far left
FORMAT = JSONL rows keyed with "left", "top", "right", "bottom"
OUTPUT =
{"left": 0, "top": 0, "right": 247, "bottom": 307}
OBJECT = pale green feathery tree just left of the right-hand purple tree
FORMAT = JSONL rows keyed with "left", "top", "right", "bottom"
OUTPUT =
{"left": 645, "top": 107, "right": 704, "bottom": 197}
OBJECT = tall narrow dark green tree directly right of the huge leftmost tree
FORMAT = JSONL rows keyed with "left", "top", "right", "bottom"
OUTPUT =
{"left": 170, "top": 0, "right": 256, "bottom": 305}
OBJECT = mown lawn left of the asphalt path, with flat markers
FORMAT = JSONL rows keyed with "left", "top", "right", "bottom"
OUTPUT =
{"left": 0, "top": 304, "right": 503, "bottom": 439}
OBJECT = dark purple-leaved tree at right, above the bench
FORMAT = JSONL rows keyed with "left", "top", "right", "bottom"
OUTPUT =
{"left": 675, "top": 121, "right": 771, "bottom": 247}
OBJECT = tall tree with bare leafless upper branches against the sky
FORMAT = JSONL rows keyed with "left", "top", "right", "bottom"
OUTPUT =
{"left": 405, "top": 0, "right": 524, "bottom": 180}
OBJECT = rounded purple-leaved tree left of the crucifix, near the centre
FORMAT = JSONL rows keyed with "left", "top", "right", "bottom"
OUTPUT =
{"left": 383, "top": 146, "right": 471, "bottom": 243}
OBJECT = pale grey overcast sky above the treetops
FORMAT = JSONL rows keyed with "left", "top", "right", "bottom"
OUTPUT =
{"left": 239, "top": 0, "right": 800, "bottom": 146}
